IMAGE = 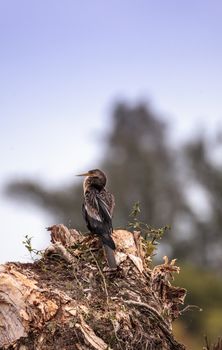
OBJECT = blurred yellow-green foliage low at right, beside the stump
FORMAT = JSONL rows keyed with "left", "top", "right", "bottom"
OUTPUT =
{"left": 175, "top": 265, "right": 222, "bottom": 345}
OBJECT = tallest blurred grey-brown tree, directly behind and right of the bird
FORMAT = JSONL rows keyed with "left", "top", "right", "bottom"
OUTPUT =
{"left": 102, "top": 104, "right": 189, "bottom": 234}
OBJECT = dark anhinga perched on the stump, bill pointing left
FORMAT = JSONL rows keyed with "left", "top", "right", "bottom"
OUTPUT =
{"left": 77, "top": 169, "right": 117, "bottom": 269}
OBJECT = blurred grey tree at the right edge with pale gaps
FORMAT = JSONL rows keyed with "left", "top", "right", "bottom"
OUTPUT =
{"left": 184, "top": 134, "right": 222, "bottom": 269}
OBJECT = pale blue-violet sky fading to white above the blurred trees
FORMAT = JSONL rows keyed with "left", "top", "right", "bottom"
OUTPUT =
{"left": 0, "top": 0, "right": 222, "bottom": 262}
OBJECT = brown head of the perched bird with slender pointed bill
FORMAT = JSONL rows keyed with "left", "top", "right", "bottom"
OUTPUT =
{"left": 76, "top": 169, "right": 106, "bottom": 192}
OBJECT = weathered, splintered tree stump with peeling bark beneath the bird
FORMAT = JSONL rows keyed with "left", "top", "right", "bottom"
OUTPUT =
{"left": 0, "top": 225, "right": 186, "bottom": 350}
